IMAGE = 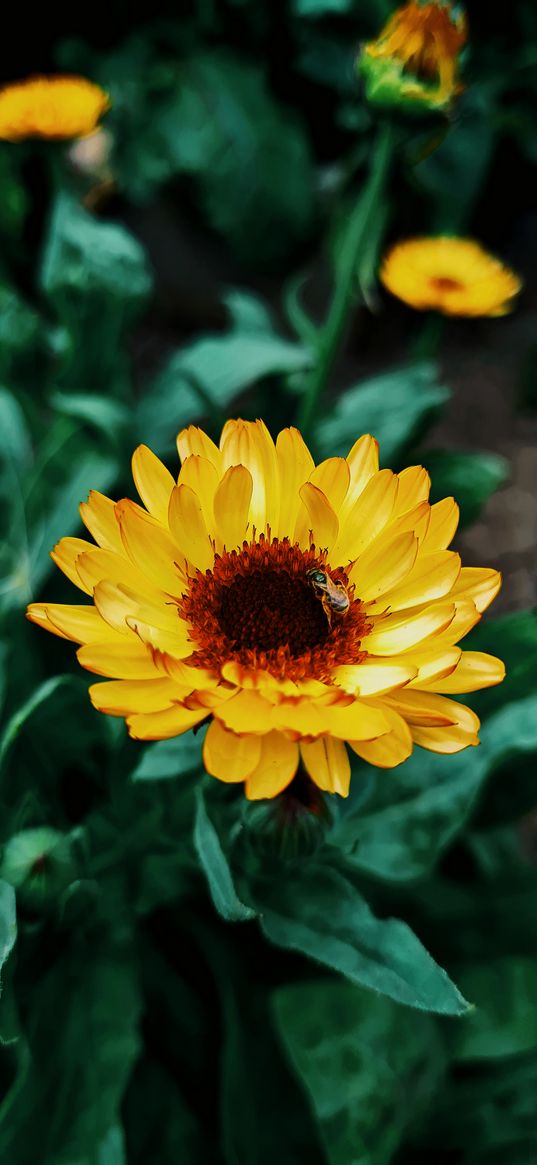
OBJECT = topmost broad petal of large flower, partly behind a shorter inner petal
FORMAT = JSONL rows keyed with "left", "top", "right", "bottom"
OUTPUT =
{"left": 220, "top": 421, "right": 280, "bottom": 536}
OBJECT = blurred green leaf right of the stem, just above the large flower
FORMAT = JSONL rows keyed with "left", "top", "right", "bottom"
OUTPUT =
{"left": 316, "top": 363, "right": 450, "bottom": 465}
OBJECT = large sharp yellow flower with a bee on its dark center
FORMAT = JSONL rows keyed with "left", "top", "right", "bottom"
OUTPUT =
{"left": 28, "top": 421, "right": 503, "bottom": 799}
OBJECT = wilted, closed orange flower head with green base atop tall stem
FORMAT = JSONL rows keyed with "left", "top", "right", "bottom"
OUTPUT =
{"left": 359, "top": 0, "right": 467, "bottom": 110}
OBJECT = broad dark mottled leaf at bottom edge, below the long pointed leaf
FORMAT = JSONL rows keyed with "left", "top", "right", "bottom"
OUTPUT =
{"left": 273, "top": 981, "right": 443, "bottom": 1165}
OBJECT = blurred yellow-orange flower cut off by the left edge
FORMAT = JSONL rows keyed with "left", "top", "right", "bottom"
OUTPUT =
{"left": 0, "top": 77, "right": 109, "bottom": 142}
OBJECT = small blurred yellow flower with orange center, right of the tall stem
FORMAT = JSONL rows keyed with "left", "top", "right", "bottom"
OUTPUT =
{"left": 380, "top": 235, "right": 522, "bottom": 316}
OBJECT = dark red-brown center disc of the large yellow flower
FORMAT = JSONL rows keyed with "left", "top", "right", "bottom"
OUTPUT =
{"left": 179, "top": 535, "right": 368, "bottom": 680}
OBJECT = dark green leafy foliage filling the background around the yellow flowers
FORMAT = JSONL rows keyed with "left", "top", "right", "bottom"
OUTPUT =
{"left": 0, "top": 0, "right": 537, "bottom": 1165}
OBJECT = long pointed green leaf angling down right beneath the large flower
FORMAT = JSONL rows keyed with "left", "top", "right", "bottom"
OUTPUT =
{"left": 252, "top": 862, "right": 468, "bottom": 1015}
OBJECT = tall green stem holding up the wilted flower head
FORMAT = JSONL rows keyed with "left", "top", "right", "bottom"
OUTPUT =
{"left": 294, "top": 121, "right": 395, "bottom": 439}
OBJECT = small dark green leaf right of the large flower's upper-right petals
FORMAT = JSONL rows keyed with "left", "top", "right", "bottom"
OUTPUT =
{"left": 423, "top": 450, "right": 509, "bottom": 528}
